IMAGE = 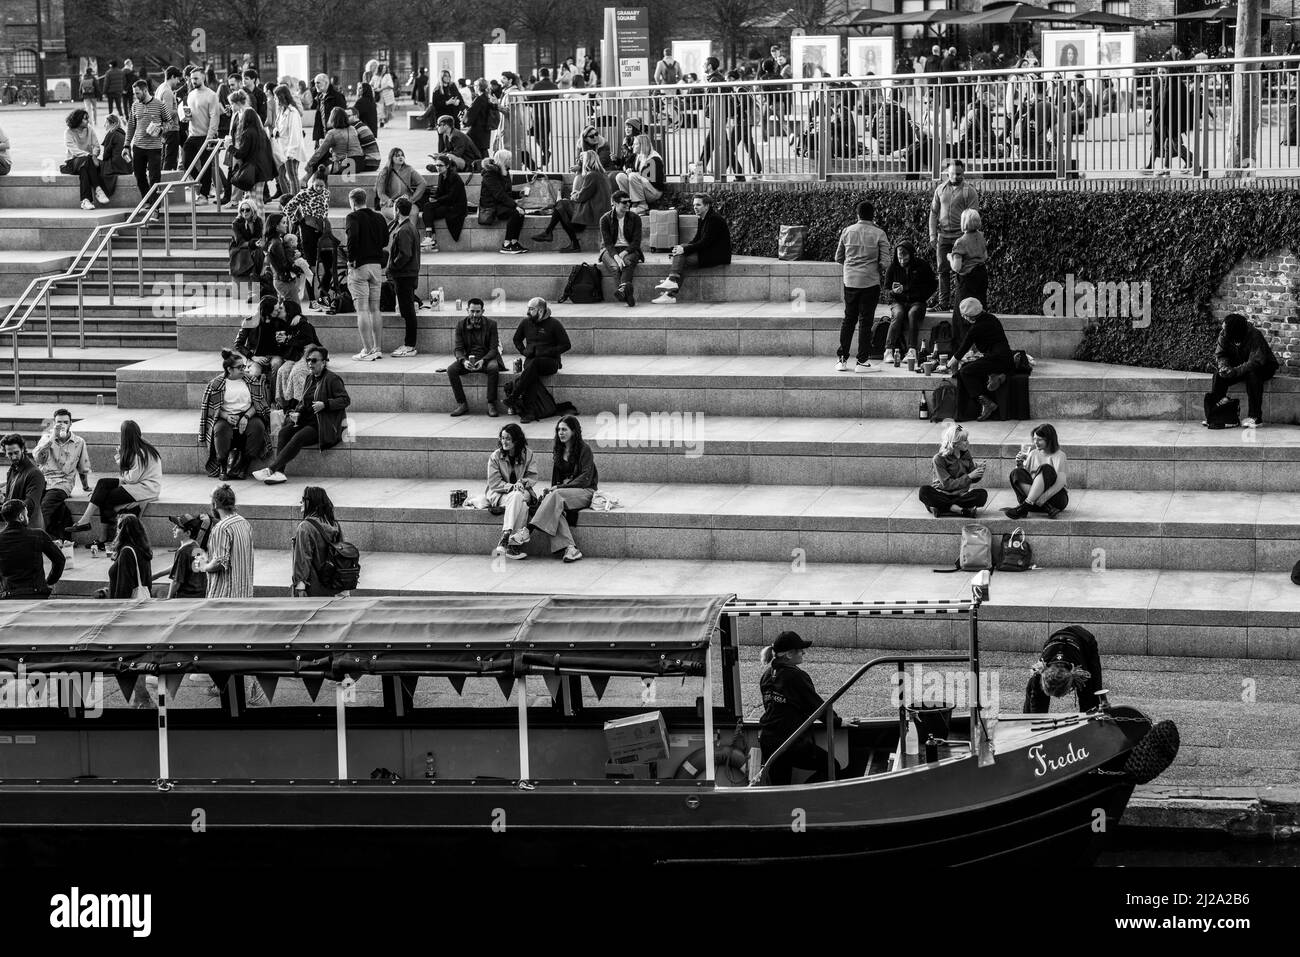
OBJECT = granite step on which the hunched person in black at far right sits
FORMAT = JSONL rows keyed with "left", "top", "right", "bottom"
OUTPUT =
{"left": 118, "top": 343, "right": 1300, "bottom": 421}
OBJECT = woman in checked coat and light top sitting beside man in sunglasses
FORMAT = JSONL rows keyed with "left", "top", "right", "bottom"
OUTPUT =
{"left": 199, "top": 348, "right": 270, "bottom": 481}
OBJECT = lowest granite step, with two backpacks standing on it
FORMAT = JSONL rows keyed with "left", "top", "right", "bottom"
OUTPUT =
{"left": 50, "top": 548, "right": 1300, "bottom": 660}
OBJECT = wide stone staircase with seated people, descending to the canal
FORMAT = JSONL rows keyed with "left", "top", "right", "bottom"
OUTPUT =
{"left": 0, "top": 167, "right": 1300, "bottom": 806}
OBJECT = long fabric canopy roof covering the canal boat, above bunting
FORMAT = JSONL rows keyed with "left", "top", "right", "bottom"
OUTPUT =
{"left": 0, "top": 594, "right": 735, "bottom": 680}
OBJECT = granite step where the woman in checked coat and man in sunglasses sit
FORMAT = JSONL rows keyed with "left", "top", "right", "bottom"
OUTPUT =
{"left": 74, "top": 408, "right": 1300, "bottom": 493}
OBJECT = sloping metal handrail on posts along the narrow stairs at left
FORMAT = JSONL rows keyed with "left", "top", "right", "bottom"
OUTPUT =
{"left": 0, "top": 147, "right": 221, "bottom": 406}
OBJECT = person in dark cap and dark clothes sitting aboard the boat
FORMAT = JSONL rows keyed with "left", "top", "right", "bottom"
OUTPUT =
{"left": 758, "top": 632, "right": 844, "bottom": 784}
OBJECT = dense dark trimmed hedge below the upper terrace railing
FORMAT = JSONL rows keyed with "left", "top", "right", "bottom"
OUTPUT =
{"left": 672, "top": 181, "right": 1300, "bottom": 372}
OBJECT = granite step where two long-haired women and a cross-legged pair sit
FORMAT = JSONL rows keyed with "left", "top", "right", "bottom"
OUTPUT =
{"left": 94, "top": 468, "right": 1300, "bottom": 566}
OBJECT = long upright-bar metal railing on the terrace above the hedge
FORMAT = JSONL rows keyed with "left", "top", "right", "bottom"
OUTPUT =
{"left": 498, "top": 57, "right": 1300, "bottom": 181}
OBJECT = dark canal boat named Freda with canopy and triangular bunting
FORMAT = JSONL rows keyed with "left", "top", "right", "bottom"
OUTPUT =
{"left": 0, "top": 580, "right": 1177, "bottom": 866}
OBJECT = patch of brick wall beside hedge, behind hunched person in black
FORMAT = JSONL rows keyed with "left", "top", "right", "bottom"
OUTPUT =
{"left": 1210, "top": 250, "right": 1300, "bottom": 378}
